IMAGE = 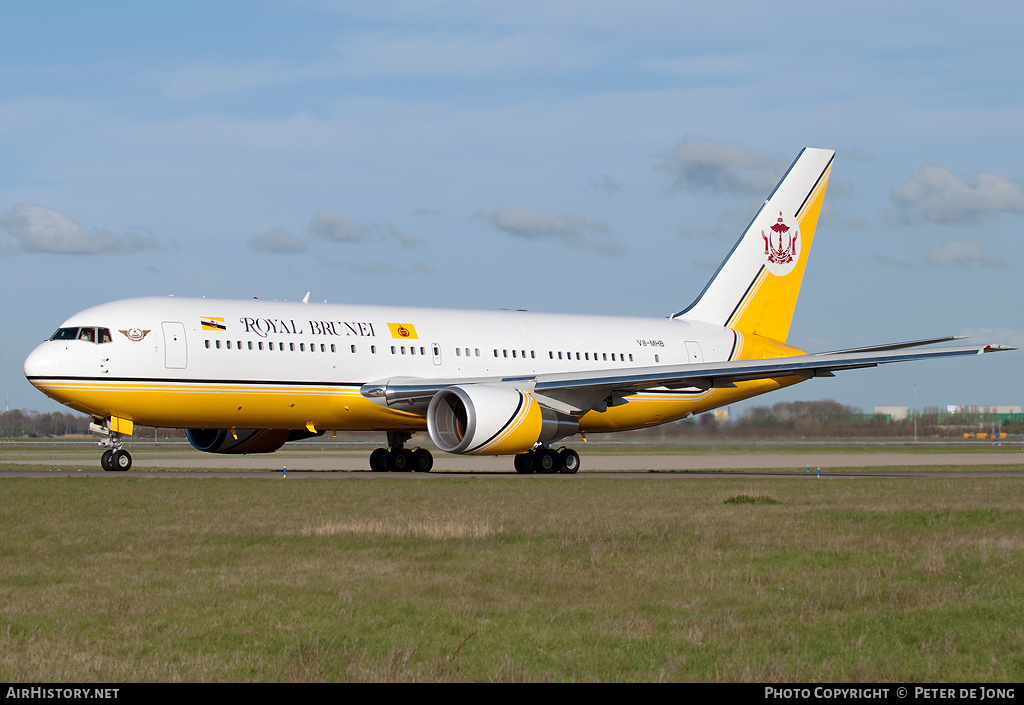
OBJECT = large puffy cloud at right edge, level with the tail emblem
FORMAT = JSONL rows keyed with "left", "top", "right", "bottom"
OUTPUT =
{"left": 889, "top": 164, "right": 1024, "bottom": 224}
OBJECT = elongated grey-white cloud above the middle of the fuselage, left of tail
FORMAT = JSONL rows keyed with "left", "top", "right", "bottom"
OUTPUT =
{"left": 473, "top": 206, "right": 626, "bottom": 257}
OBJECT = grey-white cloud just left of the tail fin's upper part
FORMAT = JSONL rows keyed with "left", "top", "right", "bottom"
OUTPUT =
{"left": 657, "top": 139, "right": 785, "bottom": 198}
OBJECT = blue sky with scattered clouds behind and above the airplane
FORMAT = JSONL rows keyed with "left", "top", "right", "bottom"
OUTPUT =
{"left": 0, "top": 0, "right": 1024, "bottom": 411}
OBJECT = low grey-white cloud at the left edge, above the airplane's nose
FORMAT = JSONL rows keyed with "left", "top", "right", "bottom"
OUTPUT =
{"left": 0, "top": 203, "right": 158, "bottom": 254}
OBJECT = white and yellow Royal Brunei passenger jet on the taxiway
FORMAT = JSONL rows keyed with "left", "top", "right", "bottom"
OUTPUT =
{"left": 25, "top": 148, "right": 1014, "bottom": 473}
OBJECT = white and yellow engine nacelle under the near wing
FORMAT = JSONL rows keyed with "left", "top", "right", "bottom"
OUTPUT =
{"left": 427, "top": 384, "right": 580, "bottom": 455}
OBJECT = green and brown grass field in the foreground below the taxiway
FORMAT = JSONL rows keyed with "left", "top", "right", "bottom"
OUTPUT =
{"left": 0, "top": 475, "right": 1024, "bottom": 681}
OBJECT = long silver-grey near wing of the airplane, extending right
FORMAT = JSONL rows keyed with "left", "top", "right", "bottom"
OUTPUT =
{"left": 360, "top": 337, "right": 1016, "bottom": 414}
